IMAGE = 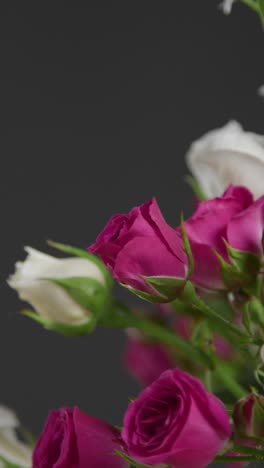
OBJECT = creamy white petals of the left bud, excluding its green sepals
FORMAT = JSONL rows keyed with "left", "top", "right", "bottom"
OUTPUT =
{"left": 8, "top": 247, "right": 105, "bottom": 325}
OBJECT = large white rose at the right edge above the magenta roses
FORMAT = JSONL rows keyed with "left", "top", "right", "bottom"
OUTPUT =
{"left": 186, "top": 121, "right": 264, "bottom": 198}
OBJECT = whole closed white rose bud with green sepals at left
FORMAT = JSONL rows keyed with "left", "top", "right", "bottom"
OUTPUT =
{"left": 8, "top": 244, "right": 109, "bottom": 334}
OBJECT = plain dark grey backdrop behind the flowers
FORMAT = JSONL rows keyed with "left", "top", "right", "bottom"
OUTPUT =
{"left": 0, "top": 0, "right": 264, "bottom": 464}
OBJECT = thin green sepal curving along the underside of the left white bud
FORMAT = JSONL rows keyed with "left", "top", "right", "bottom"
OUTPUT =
{"left": 22, "top": 310, "right": 97, "bottom": 336}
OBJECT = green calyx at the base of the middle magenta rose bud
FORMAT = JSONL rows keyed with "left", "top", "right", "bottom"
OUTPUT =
{"left": 143, "top": 276, "right": 186, "bottom": 302}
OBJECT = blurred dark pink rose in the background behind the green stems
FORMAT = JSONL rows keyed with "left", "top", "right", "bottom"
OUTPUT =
{"left": 123, "top": 337, "right": 174, "bottom": 387}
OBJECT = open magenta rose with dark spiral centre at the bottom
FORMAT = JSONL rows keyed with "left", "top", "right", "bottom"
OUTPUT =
{"left": 122, "top": 369, "right": 231, "bottom": 468}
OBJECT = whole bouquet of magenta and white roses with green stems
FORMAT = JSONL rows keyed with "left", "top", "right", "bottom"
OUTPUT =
{"left": 0, "top": 0, "right": 264, "bottom": 468}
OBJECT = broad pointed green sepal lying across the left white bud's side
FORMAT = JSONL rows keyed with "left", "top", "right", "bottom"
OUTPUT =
{"left": 45, "top": 276, "right": 109, "bottom": 317}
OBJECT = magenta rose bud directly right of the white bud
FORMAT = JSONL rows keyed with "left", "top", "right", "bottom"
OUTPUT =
{"left": 89, "top": 198, "right": 187, "bottom": 294}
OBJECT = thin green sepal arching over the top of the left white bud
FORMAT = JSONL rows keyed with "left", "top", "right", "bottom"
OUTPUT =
{"left": 47, "top": 240, "right": 113, "bottom": 289}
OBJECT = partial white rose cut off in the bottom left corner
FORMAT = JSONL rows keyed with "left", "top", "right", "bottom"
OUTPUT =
{"left": 0, "top": 406, "right": 32, "bottom": 468}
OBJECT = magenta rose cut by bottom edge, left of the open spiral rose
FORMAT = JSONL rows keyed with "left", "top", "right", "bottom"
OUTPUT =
{"left": 32, "top": 407, "right": 128, "bottom": 468}
